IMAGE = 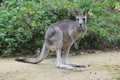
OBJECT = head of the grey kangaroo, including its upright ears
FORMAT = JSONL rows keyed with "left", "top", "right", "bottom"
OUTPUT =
{"left": 74, "top": 9, "right": 89, "bottom": 27}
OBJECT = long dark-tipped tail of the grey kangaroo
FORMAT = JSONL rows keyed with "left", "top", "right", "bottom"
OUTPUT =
{"left": 15, "top": 42, "right": 49, "bottom": 64}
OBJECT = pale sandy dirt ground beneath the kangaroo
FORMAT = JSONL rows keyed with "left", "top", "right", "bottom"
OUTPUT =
{"left": 0, "top": 51, "right": 120, "bottom": 80}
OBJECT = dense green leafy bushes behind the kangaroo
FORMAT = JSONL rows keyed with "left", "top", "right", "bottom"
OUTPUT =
{"left": 0, "top": 0, "right": 120, "bottom": 57}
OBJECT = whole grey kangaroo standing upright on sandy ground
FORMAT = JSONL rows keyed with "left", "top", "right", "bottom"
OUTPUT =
{"left": 16, "top": 9, "right": 89, "bottom": 69}
